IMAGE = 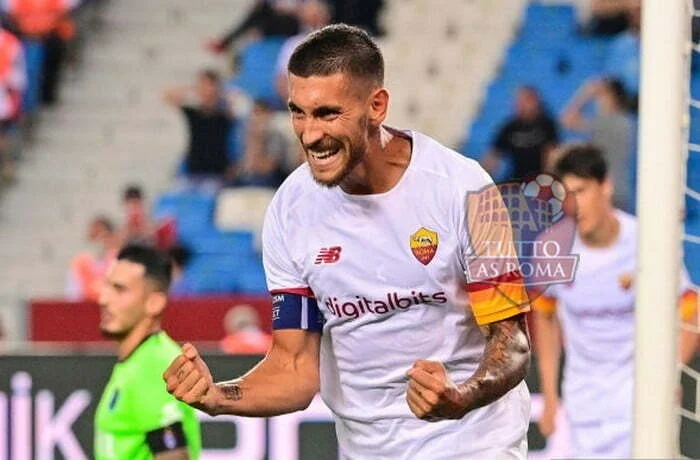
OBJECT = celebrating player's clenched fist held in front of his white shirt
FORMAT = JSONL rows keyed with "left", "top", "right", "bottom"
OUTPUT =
{"left": 406, "top": 359, "right": 467, "bottom": 422}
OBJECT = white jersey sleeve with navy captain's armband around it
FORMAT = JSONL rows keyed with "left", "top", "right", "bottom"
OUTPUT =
{"left": 262, "top": 193, "right": 323, "bottom": 332}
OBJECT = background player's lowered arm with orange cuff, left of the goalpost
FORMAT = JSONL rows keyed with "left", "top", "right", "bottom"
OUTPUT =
{"left": 533, "top": 296, "right": 561, "bottom": 436}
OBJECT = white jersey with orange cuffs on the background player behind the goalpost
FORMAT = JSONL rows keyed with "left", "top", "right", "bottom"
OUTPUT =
{"left": 534, "top": 210, "right": 694, "bottom": 426}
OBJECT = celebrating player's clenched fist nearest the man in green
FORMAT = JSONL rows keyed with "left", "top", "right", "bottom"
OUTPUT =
{"left": 163, "top": 343, "right": 221, "bottom": 415}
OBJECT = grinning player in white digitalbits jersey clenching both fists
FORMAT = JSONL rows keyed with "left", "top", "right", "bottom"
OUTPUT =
{"left": 164, "top": 25, "right": 530, "bottom": 459}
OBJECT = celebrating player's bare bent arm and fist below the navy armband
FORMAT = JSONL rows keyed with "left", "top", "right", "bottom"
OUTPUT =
{"left": 163, "top": 329, "right": 320, "bottom": 417}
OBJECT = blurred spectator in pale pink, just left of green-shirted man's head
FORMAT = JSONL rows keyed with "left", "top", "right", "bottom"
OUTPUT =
{"left": 66, "top": 216, "right": 120, "bottom": 301}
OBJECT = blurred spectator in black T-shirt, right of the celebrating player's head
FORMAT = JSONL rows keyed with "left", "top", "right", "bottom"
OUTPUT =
{"left": 481, "top": 86, "right": 559, "bottom": 179}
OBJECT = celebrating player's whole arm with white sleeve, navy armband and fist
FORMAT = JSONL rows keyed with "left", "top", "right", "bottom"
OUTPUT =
{"left": 164, "top": 185, "right": 323, "bottom": 417}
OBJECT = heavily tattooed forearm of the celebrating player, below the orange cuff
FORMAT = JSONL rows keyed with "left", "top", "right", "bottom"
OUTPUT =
{"left": 461, "top": 314, "right": 530, "bottom": 412}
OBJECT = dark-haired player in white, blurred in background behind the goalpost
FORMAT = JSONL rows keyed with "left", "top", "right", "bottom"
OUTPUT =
{"left": 533, "top": 144, "right": 697, "bottom": 458}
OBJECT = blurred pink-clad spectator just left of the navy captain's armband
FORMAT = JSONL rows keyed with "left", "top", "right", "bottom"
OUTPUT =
{"left": 219, "top": 305, "right": 272, "bottom": 355}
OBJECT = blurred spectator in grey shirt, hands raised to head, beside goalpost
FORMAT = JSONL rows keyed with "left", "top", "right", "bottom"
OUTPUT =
{"left": 561, "top": 79, "right": 634, "bottom": 212}
